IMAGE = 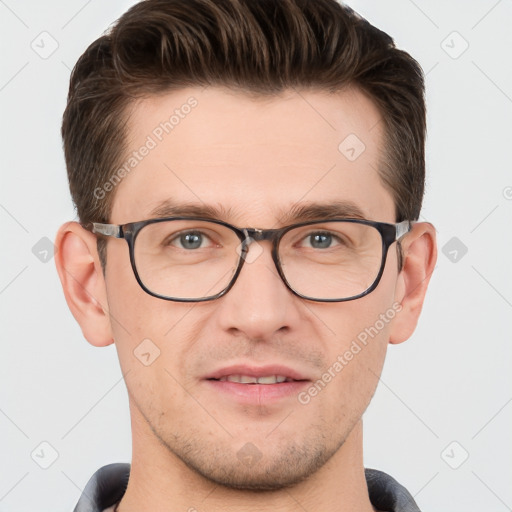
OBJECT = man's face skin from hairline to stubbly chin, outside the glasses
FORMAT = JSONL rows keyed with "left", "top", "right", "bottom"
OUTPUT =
{"left": 105, "top": 87, "right": 398, "bottom": 489}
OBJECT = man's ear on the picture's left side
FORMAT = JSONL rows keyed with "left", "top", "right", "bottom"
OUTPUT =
{"left": 55, "top": 222, "right": 114, "bottom": 347}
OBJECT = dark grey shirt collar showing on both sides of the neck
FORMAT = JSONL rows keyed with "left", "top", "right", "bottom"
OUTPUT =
{"left": 74, "top": 463, "right": 421, "bottom": 512}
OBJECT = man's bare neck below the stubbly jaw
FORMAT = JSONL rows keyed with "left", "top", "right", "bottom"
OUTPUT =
{"left": 117, "top": 404, "right": 375, "bottom": 512}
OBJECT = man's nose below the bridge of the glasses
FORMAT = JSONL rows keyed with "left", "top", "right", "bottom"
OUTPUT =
{"left": 216, "top": 241, "right": 301, "bottom": 340}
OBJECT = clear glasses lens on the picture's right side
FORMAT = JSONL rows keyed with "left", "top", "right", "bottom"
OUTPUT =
{"left": 279, "top": 221, "right": 382, "bottom": 300}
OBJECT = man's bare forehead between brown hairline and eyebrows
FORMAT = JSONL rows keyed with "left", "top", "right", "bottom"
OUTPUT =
{"left": 111, "top": 86, "right": 394, "bottom": 226}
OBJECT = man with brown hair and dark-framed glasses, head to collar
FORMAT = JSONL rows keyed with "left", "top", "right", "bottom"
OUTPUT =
{"left": 56, "top": 0, "right": 436, "bottom": 512}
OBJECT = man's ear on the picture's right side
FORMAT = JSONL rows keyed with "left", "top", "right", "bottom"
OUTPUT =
{"left": 389, "top": 222, "right": 437, "bottom": 343}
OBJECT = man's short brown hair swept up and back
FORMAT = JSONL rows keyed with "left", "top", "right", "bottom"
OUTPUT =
{"left": 62, "top": 0, "right": 426, "bottom": 265}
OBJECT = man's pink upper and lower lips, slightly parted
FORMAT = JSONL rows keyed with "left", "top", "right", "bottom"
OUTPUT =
{"left": 203, "top": 364, "right": 311, "bottom": 406}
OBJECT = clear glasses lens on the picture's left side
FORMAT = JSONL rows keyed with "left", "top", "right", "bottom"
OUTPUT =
{"left": 134, "top": 220, "right": 240, "bottom": 300}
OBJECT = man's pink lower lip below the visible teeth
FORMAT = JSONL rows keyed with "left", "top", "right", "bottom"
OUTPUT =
{"left": 205, "top": 380, "right": 309, "bottom": 405}
